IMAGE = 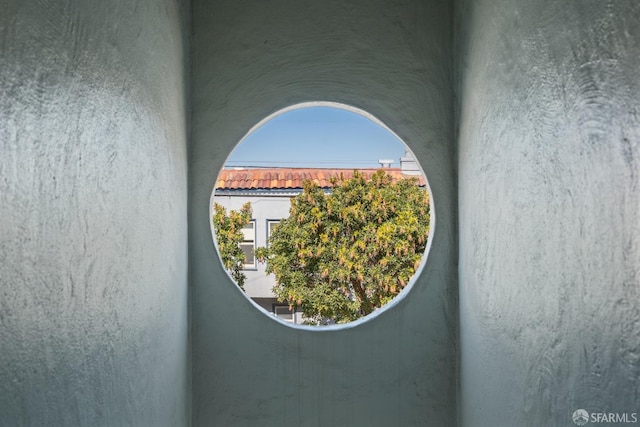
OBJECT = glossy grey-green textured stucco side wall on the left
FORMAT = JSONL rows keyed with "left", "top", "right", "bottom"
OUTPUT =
{"left": 0, "top": 0, "right": 188, "bottom": 426}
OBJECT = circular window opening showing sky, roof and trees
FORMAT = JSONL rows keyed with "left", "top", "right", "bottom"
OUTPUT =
{"left": 211, "top": 103, "right": 431, "bottom": 326}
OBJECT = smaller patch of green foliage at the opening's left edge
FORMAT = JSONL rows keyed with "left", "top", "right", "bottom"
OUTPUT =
{"left": 212, "top": 202, "right": 252, "bottom": 290}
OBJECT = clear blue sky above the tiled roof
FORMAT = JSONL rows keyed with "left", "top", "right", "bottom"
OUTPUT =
{"left": 225, "top": 107, "right": 405, "bottom": 168}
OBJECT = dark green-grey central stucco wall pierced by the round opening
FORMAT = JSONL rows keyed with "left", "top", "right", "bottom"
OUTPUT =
{"left": 189, "top": 0, "right": 457, "bottom": 427}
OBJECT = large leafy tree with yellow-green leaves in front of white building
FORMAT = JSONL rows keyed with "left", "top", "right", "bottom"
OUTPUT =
{"left": 257, "top": 170, "right": 430, "bottom": 324}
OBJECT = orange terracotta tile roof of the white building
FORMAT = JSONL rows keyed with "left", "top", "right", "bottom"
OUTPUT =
{"left": 216, "top": 168, "right": 426, "bottom": 190}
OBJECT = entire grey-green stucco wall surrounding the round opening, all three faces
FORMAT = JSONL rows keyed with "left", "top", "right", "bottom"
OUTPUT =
{"left": 0, "top": 0, "right": 640, "bottom": 427}
